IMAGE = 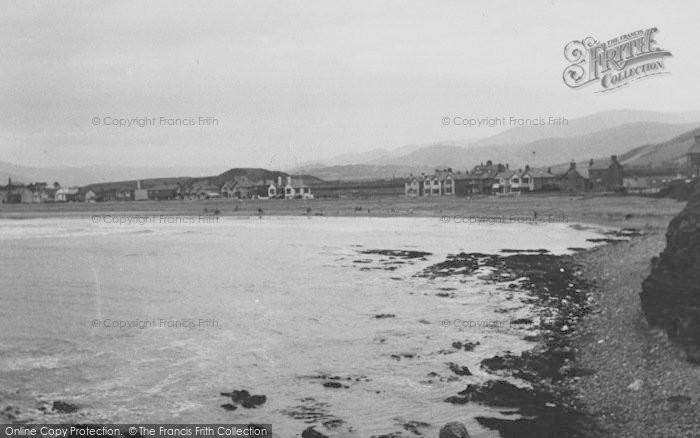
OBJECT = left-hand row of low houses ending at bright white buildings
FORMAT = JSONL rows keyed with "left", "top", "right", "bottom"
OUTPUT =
{"left": 0, "top": 175, "right": 313, "bottom": 204}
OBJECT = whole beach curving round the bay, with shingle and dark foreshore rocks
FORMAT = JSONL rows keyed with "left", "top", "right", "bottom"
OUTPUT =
{"left": 0, "top": 196, "right": 700, "bottom": 438}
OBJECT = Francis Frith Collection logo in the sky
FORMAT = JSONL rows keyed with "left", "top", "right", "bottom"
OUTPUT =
{"left": 564, "top": 27, "right": 672, "bottom": 93}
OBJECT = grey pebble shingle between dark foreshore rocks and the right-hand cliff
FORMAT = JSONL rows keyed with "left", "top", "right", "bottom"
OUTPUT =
{"left": 570, "top": 232, "right": 700, "bottom": 437}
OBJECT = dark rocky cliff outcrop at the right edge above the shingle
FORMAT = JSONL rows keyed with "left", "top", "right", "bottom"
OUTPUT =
{"left": 640, "top": 181, "right": 700, "bottom": 364}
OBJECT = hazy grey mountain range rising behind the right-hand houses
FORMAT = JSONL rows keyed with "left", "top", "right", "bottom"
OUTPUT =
{"left": 293, "top": 110, "right": 700, "bottom": 180}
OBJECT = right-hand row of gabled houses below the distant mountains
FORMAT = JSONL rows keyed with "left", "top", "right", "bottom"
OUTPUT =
{"left": 405, "top": 155, "right": 624, "bottom": 197}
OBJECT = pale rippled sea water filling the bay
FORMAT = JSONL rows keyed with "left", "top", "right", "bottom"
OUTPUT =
{"left": 0, "top": 215, "right": 601, "bottom": 437}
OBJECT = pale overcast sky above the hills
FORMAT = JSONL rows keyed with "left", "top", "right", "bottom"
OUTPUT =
{"left": 0, "top": 0, "right": 700, "bottom": 169}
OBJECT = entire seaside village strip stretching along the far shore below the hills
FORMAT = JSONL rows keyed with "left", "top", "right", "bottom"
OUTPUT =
{"left": 0, "top": 136, "right": 700, "bottom": 204}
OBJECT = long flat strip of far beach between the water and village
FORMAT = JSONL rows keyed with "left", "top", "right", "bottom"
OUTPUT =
{"left": 0, "top": 194, "right": 685, "bottom": 230}
